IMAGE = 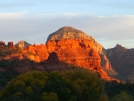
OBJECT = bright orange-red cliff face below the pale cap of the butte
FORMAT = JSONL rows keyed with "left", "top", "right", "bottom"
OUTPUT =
{"left": 46, "top": 39, "right": 114, "bottom": 80}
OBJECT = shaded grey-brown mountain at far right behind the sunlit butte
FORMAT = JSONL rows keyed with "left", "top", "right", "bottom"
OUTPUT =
{"left": 106, "top": 44, "right": 134, "bottom": 82}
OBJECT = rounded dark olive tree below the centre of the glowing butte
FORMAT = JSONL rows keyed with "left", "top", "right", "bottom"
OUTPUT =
{"left": 62, "top": 68, "right": 103, "bottom": 101}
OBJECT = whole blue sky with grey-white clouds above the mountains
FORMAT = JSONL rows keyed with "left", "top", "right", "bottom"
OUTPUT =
{"left": 0, "top": 0, "right": 134, "bottom": 49}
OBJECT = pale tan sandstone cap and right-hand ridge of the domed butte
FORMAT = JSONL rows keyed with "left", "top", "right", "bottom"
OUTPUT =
{"left": 47, "top": 27, "right": 117, "bottom": 75}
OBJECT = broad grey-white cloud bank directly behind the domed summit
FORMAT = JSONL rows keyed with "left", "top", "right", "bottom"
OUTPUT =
{"left": 0, "top": 11, "right": 134, "bottom": 48}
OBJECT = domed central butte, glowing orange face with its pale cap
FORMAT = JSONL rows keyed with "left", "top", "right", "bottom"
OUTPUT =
{"left": 46, "top": 27, "right": 116, "bottom": 79}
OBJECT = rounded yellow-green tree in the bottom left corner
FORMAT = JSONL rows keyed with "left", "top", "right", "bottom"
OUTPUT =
{"left": 1, "top": 71, "right": 47, "bottom": 101}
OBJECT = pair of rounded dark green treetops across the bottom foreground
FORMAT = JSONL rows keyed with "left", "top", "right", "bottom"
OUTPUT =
{"left": 0, "top": 69, "right": 107, "bottom": 101}
